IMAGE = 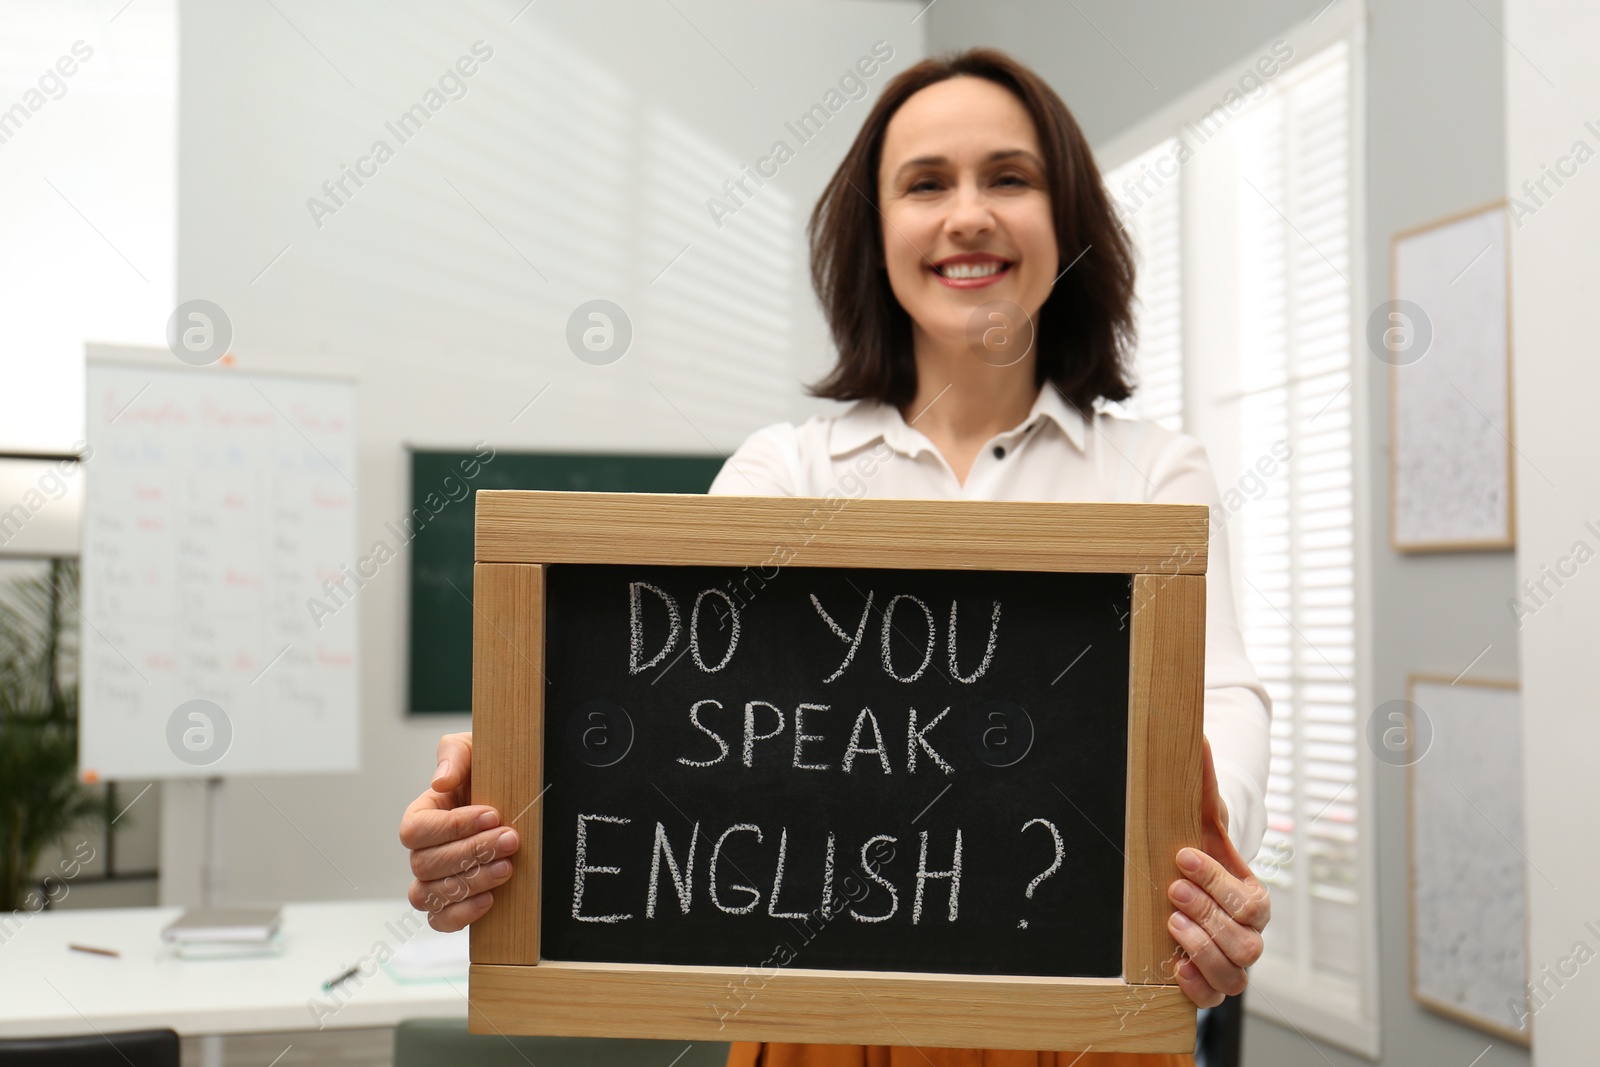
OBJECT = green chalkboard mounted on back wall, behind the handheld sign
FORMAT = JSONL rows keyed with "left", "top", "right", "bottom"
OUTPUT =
{"left": 406, "top": 445, "right": 723, "bottom": 713}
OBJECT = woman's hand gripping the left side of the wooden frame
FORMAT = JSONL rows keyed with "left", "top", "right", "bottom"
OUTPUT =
{"left": 400, "top": 731, "right": 520, "bottom": 933}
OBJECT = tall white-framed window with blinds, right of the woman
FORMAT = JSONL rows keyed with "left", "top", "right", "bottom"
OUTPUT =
{"left": 1101, "top": 2, "right": 1378, "bottom": 1057}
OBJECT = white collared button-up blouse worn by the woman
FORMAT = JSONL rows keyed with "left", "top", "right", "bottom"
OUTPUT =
{"left": 710, "top": 386, "right": 1272, "bottom": 859}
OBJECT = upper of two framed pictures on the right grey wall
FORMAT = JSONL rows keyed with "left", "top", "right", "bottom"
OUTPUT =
{"left": 1388, "top": 200, "right": 1515, "bottom": 552}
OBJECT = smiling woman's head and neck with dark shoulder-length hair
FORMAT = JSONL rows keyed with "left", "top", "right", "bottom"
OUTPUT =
{"left": 811, "top": 50, "right": 1134, "bottom": 460}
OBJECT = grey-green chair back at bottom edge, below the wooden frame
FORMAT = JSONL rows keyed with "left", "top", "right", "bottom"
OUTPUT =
{"left": 394, "top": 1019, "right": 728, "bottom": 1067}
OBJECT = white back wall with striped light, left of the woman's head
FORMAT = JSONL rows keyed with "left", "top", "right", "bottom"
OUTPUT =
{"left": 162, "top": 0, "right": 923, "bottom": 902}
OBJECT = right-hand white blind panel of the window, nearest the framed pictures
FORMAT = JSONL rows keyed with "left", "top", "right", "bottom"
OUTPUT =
{"left": 1235, "top": 43, "right": 1362, "bottom": 979}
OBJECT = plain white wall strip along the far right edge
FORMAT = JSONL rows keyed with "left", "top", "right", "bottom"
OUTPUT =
{"left": 1502, "top": 0, "right": 1600, "bottom": 1067}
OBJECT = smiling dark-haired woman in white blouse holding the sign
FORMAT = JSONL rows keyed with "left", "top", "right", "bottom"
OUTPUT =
{"left": 400, "top": 50, "right": 1270, "bottom": 1067}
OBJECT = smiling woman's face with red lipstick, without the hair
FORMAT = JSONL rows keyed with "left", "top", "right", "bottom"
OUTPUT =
{"left": 878, "top": 77, "right": 1059, "bottom": 358}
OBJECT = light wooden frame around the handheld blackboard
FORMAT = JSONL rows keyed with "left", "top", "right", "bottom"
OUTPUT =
{"left": 469, "top": 490, "right": 1210, "bottom": 1053}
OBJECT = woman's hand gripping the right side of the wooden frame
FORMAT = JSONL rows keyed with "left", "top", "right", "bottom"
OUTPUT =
{"left": 1166, "top": 737, "right": 1272, "bottom": 1008}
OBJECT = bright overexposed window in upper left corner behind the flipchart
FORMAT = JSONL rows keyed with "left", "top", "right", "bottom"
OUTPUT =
{"left": 0, "top": 0, "right": 178, "bottom": 454}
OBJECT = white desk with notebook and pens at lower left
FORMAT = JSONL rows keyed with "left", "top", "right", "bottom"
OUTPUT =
{"left": 0, "top": 901, "right": 467, "bottom": 1037}
